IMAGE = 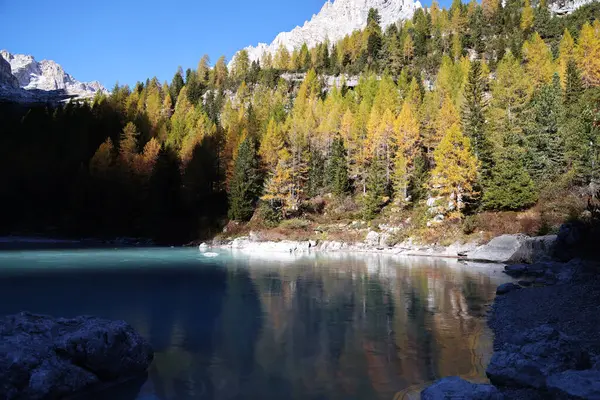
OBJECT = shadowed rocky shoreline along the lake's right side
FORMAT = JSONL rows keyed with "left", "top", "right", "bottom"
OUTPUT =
{"left": 421, "top": 228, "right": 600, "bottom": 400}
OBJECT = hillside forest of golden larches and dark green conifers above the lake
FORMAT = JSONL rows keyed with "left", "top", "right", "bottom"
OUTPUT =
{"left": 0, "top": 0, "right": 600, "bottom": 243}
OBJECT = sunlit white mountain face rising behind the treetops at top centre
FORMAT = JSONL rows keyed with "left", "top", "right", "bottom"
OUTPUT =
{"left": 240, "top": 0, "right": 421, "bottom": 61}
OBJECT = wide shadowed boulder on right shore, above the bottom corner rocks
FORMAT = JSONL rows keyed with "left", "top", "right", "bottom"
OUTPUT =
{"left": 486, "top": 325, "right": 590, "bottom": 389}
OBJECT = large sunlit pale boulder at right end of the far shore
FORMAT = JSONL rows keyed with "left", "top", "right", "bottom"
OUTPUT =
{"left": 467, "top": 235, "right": 556, "bottom": 263}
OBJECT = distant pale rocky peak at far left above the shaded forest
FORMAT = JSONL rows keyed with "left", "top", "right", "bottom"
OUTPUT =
{"left": 0, "top": 50, "right": 108, "bottom": 98}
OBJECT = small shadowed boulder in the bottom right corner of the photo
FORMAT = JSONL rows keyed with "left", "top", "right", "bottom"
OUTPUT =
{"left": 546, "top": 370, "right": 600, "bottom": 400}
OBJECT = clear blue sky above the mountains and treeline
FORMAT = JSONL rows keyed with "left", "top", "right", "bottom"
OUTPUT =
{"left": 0, "top": 0, "right": 446, "bottom": 89}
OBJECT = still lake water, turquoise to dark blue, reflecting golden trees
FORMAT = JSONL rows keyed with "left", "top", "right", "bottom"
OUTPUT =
{"left": 0, "top": 249, "right": 506, "bottom": 400}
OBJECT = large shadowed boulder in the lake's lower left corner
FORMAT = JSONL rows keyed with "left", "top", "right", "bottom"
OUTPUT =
{"left": 0, "top": 313, "right": 153, "bottom": 400}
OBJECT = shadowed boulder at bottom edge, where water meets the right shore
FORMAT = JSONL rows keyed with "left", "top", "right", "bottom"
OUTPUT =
{"left": 421, "top": 376, "right": 504, "bottom": 400}
